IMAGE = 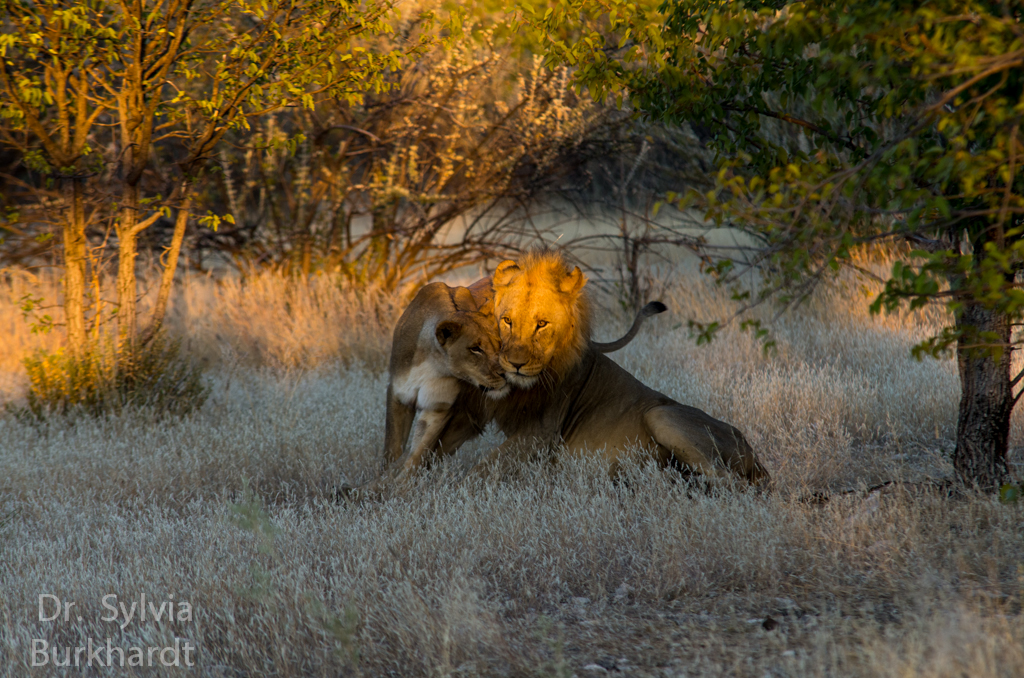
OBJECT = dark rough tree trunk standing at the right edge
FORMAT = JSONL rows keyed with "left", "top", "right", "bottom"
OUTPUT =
{"left": 953, "top": 303, "right": 1014, "bottom": 492}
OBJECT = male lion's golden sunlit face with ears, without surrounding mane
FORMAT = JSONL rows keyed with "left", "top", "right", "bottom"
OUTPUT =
{"left": 494, "top": 261, "right": 586, "bottom": 388}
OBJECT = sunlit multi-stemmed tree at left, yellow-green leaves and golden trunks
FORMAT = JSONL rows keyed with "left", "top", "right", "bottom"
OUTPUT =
{"left": 0, "top": 0, "right": 434, "bottom": 350}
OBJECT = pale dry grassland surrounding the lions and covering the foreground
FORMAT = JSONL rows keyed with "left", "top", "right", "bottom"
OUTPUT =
{"left": 0, "top": 262, "right": 1024, "bottom": 678}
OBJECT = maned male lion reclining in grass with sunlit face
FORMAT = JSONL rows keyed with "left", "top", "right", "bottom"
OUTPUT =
{"left": 477, "top": 254, "right": 769, "bottom": 483}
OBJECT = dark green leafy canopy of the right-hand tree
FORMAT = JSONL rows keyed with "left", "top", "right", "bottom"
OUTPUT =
{"left": 521, "top": 0, "right": 1024, "bottom": 354}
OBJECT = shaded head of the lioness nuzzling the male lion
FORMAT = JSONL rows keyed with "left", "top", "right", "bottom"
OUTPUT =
{"left": 434, "top": 312, "right": 509, "bottom": 398}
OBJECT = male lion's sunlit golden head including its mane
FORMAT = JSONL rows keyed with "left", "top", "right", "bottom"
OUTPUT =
{"left": 493, "top": 253, "right": 590, "bottom": 388}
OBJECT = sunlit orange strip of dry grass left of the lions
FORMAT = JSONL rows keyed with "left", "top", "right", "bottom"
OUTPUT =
{"left": 0, "top": 270, "right": 401, "bottom": 398}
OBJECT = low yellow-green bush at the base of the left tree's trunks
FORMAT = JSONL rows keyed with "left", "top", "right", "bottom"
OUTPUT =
{"left": 17, "top": 336, "right": 209, "bottom": 421}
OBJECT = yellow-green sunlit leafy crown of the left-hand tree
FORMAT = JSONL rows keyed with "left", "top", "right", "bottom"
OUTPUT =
{"left": 0, "top": 0, "right": 423, "bottom": 176}
